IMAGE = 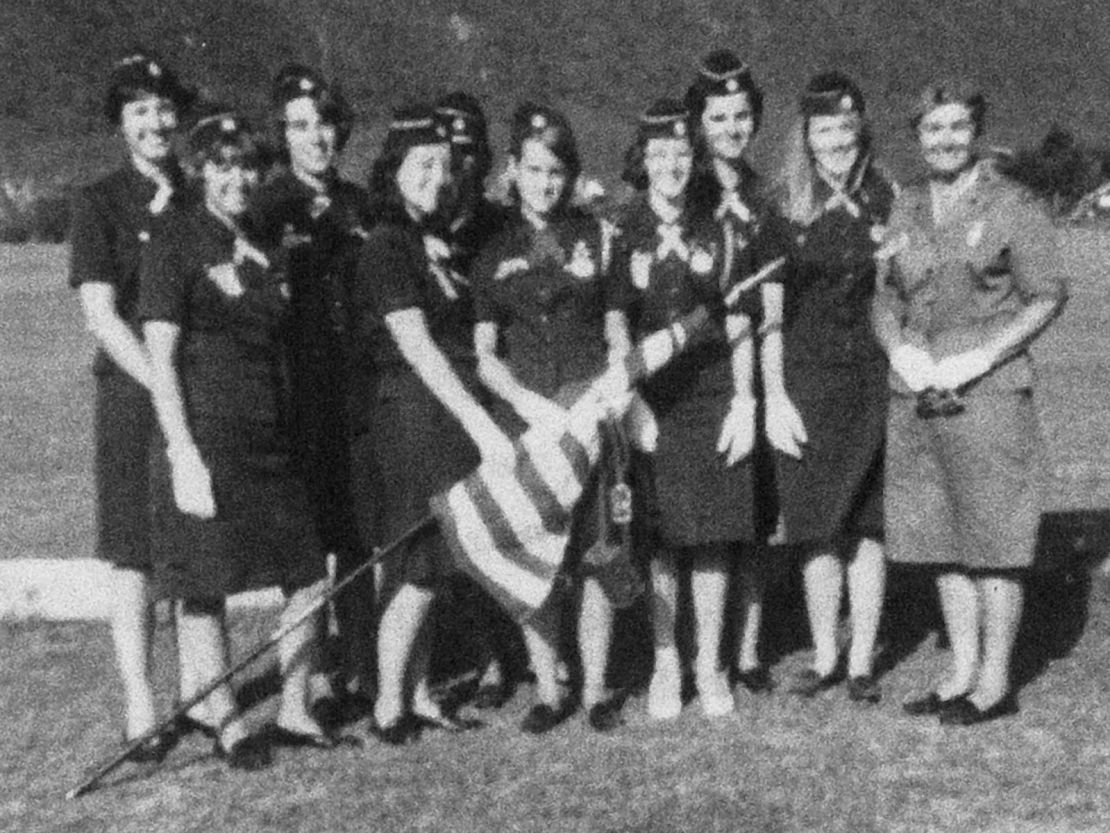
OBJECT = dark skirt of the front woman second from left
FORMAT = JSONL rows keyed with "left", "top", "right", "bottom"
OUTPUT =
{"left": 151, "top": 432, "right": 325, "bottom": 601}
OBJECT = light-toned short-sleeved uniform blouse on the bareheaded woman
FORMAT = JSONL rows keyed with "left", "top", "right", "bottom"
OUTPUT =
{"left": 880, "top": 162, "right": 1067, "bottom": 393}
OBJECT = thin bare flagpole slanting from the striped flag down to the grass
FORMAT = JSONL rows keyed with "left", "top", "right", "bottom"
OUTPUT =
{"left": 65, "top": 514, "right": 435, "bottom": 801}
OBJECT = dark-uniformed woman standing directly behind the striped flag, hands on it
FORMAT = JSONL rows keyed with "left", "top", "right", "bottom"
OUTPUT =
{"left": 472, "top": 104, "right": 628, "bottom": 734}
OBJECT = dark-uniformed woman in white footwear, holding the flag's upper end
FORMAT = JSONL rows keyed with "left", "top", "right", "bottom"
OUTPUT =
{"left": 614, "top": 100, "right": 755, "bottom": 719}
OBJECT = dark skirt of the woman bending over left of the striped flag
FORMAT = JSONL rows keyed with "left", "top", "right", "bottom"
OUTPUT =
{"left": 352, "top": 373, "right": 481, "bottom": 593}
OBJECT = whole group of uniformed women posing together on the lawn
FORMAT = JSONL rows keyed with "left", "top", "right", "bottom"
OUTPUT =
{"left": 71, "top": 44, "right": 1064, "bottom": 769}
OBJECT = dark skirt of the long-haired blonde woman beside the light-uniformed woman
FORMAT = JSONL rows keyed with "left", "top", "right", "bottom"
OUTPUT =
{"left": 775, "top": 363, "right": 889, "bottom": 544}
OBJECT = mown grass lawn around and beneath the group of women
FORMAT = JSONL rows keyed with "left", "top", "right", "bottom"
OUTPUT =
{"left": 0, "top": 236, "right": 1110, "bottom": 833}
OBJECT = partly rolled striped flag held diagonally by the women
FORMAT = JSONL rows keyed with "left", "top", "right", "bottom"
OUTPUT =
{"left": 431, "top": 258, "right": 783, "bottom": 621}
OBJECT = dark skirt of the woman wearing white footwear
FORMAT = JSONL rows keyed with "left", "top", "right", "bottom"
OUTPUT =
{"left": 636, "top": 391, "right": 756, "bottom": 548}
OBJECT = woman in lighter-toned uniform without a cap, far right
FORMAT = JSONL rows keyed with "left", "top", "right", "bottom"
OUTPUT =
{"left": 874, "top": 82, "right": 1067, "bottom": 725}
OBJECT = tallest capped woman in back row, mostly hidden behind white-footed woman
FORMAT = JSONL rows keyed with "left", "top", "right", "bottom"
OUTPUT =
{"left": 685, "top": 50, "right": 805, "bottom": 703}
